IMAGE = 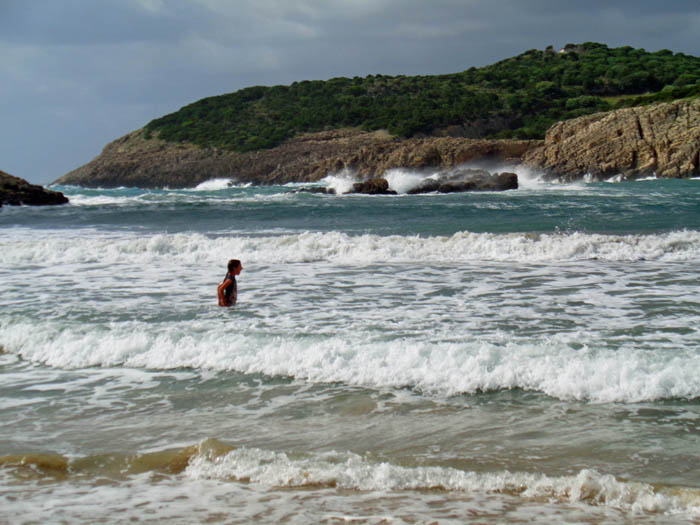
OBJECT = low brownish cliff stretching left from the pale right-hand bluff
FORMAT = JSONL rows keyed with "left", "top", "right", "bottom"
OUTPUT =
{"left": 56, "top": 129, "right": 536, "bottom": 188}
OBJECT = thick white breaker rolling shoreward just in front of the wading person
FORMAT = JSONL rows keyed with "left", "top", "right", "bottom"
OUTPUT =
{"left": 0, "top": 312, "right": 700, "bottom": 402}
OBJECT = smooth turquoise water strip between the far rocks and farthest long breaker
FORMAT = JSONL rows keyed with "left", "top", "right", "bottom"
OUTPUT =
{"left": 8, "top": 176, "right": 700, "bottom": 236}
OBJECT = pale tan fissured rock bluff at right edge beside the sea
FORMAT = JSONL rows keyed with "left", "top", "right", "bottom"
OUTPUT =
{"left": 524, "top": 99, "right": 700, "bottom": 180}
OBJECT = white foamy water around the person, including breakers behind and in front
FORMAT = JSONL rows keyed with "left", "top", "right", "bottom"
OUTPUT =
{"left": 0, "top": 224, "right": 700, "bottom": 402}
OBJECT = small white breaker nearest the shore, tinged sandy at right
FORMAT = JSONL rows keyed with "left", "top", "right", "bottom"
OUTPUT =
{"left": 186, "top": 448, "right": 700, "bottom": 516}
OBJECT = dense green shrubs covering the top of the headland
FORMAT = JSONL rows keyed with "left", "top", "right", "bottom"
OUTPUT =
{"left": 146, "top": 42, "right": 700, "bottom": 151}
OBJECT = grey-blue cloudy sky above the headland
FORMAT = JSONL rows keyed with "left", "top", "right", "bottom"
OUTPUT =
{"left": 0, "top": 0, "right": 700, "bottom": 184}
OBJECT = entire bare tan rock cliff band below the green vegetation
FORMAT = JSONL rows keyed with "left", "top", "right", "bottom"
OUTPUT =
{"left": 56, "top": 99, "right": 700, "bottom": 188}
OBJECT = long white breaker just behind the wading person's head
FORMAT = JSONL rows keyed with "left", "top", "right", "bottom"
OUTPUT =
{"left": 0, "top": 230, "right": 700, "bottom": 264}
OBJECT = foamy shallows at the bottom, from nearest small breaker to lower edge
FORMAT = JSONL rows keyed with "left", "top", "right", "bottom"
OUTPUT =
{"left": 8, "top": 448, "right": 700, "bottom": 524}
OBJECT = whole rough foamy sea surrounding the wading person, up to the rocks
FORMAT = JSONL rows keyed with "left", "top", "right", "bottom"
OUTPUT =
{"left": 0, "top": 168, "right": 700, "bottom": 524}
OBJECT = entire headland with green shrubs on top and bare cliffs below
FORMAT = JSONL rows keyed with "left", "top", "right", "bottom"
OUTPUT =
{"left": 56, "top": 44, "right": 700, "bottom": 188}
